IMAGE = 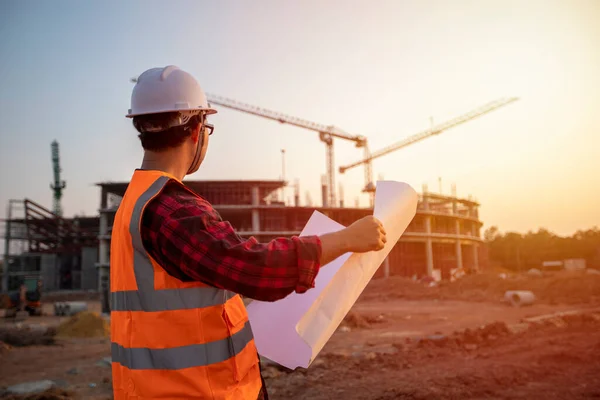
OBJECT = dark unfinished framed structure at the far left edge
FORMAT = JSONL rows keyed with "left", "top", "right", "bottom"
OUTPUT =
{"left": 0, "top": 199, "right": 99, "bottom": 291}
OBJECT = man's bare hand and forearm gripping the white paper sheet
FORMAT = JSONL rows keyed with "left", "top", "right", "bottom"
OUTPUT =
{"left": 320, "top": 216, "right": 387, "bottom": 265}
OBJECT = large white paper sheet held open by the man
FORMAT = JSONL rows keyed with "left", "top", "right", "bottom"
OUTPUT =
{"left": 247, "top": 181, "right": 418, "bottom": 369}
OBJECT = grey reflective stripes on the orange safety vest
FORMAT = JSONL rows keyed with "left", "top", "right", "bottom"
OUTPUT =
{"left": 111, "top": 176, "right": 253, "bottom": 370}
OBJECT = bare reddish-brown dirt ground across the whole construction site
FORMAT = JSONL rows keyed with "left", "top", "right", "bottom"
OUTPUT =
{"left": 0, "top": 272, "right": 600, "bottom": 400}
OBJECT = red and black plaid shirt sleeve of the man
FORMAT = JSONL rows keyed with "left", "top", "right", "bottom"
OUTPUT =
{"left": 141, "top": 183, "right": 321, "bottom": 301}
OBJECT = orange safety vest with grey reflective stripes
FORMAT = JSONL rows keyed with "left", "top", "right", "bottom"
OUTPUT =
{"left": 110, "top": 170, "right": 262, "bottom": 400}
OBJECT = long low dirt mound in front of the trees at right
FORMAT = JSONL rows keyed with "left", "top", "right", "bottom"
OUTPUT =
{"left": 361, "top": 271, "right": 600, "bottom": 304}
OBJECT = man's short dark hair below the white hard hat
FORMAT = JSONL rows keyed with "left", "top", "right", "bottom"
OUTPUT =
{"left": 133, "top": 112, "right": 203, "bottom": 152}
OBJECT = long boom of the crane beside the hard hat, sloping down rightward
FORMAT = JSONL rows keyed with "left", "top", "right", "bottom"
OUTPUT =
{"left": 207, "top": 94, "right": 366, "bottom": 147}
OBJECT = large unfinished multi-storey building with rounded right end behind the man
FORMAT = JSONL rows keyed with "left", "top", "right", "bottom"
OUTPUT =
{"left": 98, "top": 181, "right": 487, "bottom": 310}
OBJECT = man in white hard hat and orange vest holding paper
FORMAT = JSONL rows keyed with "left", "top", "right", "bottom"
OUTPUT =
{"left": 110, "top": 66, "right": 386, "bottom": 400}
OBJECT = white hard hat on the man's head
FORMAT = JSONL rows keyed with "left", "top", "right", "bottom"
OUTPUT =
{"left": 127, "top": 65, "right": 217, "bottom": 118}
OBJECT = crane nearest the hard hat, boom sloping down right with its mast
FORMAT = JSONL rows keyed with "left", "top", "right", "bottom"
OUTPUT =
{"left": 207, "top": 94, "right": 370, "bottom": 207}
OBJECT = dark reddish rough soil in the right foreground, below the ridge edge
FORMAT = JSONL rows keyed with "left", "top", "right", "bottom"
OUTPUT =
{"left": 267, "top": 312, "right": 600, "bottom": 400}
